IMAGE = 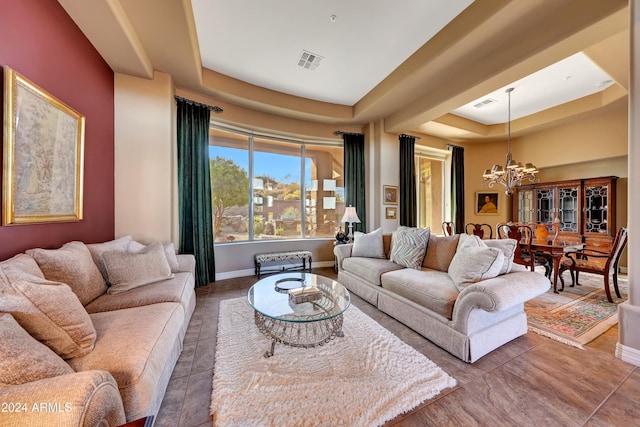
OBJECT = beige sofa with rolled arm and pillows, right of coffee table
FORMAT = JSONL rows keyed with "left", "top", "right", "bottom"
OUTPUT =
{"left": 334, "top": 227, "right": 550, "bottom": 362}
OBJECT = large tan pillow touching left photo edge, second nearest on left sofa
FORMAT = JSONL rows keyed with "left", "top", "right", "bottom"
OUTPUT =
{"left": 0, "top": 267, "right": 96, "bottom": 359}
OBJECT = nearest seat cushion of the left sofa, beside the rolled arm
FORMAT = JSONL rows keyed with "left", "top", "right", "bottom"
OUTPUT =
{"left": 68, "top": 302, "right": 185, "bottom": 419}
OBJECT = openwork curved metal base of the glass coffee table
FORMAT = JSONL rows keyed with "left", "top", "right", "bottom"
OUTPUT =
{"left": 253, "top": 311, "right": 344, "bottom": 357}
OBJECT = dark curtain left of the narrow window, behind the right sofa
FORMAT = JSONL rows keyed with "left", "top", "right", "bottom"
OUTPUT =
{"left": 398, "top": 134, "right": 418, "bottom": 227}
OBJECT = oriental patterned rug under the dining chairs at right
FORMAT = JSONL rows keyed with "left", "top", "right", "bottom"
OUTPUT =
{"left": 524, "top": 273, "right": 628, "bottom": 348}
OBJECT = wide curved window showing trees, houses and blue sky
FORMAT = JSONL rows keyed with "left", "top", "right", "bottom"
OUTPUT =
{"left": 209, "top": 127, "right": 344, "bottom": 243}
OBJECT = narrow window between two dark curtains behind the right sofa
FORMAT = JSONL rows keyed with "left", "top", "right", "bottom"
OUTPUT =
{"left": 415, "top": 147, "right": 450, "bottom": 233}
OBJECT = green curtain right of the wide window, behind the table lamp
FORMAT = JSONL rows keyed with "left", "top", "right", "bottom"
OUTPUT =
{"left": 342, "top": 133, "right": 367, "bottom": 233}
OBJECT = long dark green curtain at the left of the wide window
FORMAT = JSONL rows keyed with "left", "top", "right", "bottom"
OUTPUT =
{"left": 176, "top": 98, "right": 216, "bottom": 286}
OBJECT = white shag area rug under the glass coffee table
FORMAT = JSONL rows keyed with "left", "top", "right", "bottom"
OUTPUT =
{"left": 211, "top": 298, "right": 456, "bottom": 427}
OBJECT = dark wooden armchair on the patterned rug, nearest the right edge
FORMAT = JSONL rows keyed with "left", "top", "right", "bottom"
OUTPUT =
{"left": 558, "top": 227, "right": 628, "bottom": 303}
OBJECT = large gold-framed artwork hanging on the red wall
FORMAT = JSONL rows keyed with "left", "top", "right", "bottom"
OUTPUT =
{"left": 2, "top": 66, "right": 85, "bottom": 225}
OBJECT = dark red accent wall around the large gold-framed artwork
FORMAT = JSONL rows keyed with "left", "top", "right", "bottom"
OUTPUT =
{"left": 0, "top": 0, "right": 114, "bottom": 260}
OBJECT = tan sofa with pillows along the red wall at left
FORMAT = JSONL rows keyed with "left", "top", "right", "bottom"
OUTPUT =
{"left": 0, "top": 237, "right": 195, "bottom": 426}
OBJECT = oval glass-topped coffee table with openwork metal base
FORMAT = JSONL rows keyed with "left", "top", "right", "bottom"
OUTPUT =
{"left": 248, "top": 273, "right": 350, "bottom": 357}
